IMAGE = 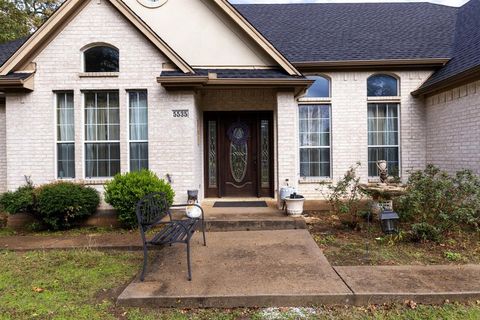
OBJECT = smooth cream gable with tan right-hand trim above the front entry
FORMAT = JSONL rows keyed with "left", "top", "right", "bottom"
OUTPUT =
{"left": 123, "top": 0, "right": 300, "bottom": 75}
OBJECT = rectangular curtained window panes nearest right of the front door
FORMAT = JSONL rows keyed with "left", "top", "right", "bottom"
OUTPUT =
{"left": 299, "top": 104, "right": 330, "bottom": 177}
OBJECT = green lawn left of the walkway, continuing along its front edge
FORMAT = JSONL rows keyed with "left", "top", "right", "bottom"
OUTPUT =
{"left": 0, "top": 250, "right": 480, "bottom": 320}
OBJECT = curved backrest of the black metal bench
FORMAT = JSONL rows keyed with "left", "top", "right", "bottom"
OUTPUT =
{"left": 136, "top": 192, "right": 170, "bottom": 230}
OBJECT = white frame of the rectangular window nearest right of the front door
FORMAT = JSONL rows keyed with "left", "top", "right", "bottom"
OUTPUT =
{"left": 297, "top": 104, "right": 333, "bottom": 184}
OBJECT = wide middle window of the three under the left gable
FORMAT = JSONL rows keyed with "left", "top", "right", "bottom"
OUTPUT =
{"left": 84, "top": 91, "right": 120, "bottom": 178}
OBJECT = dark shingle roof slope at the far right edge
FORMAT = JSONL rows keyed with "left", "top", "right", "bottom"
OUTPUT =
{"left": 420, "top": 0, "right": 480, "bottom": 90}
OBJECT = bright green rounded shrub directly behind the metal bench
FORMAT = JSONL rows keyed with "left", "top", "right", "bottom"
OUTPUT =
{"left": 105, "top": 170, "right": 175, "bottom": 228}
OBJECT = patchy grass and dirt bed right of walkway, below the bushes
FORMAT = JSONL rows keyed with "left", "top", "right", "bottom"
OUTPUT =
{"left": 307, "top": 212, "right": 480, "bottom": 266}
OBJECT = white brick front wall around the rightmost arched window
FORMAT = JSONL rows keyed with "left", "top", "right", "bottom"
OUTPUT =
{"left": 296, "top": 70, "right": 431, "bottom": 199}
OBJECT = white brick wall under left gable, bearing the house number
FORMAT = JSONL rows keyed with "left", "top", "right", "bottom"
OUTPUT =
{"left": 2, "top": 0, "right": 197, "bottom": 201}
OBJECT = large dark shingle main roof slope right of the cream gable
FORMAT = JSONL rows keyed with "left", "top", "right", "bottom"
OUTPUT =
{"left": 235, "top": 3, "right": 458, "bottom": 62}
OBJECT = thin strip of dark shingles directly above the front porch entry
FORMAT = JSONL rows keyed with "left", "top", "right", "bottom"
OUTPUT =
{"left": 161, "top": 69, "right": 299, "bottom": 79}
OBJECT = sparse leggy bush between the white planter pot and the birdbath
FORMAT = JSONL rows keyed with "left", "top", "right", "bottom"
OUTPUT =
{"left": 321, "top": 163, "right": 364, "bottom": 229}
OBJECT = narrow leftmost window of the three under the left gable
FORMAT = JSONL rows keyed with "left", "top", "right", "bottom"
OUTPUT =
{"left": 56, "top": 92, "right": 75, "bottom": 179}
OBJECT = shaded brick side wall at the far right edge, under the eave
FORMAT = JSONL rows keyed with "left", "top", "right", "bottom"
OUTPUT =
{"left": 426, "top": 81, "right": 480, "bottom": 174}
